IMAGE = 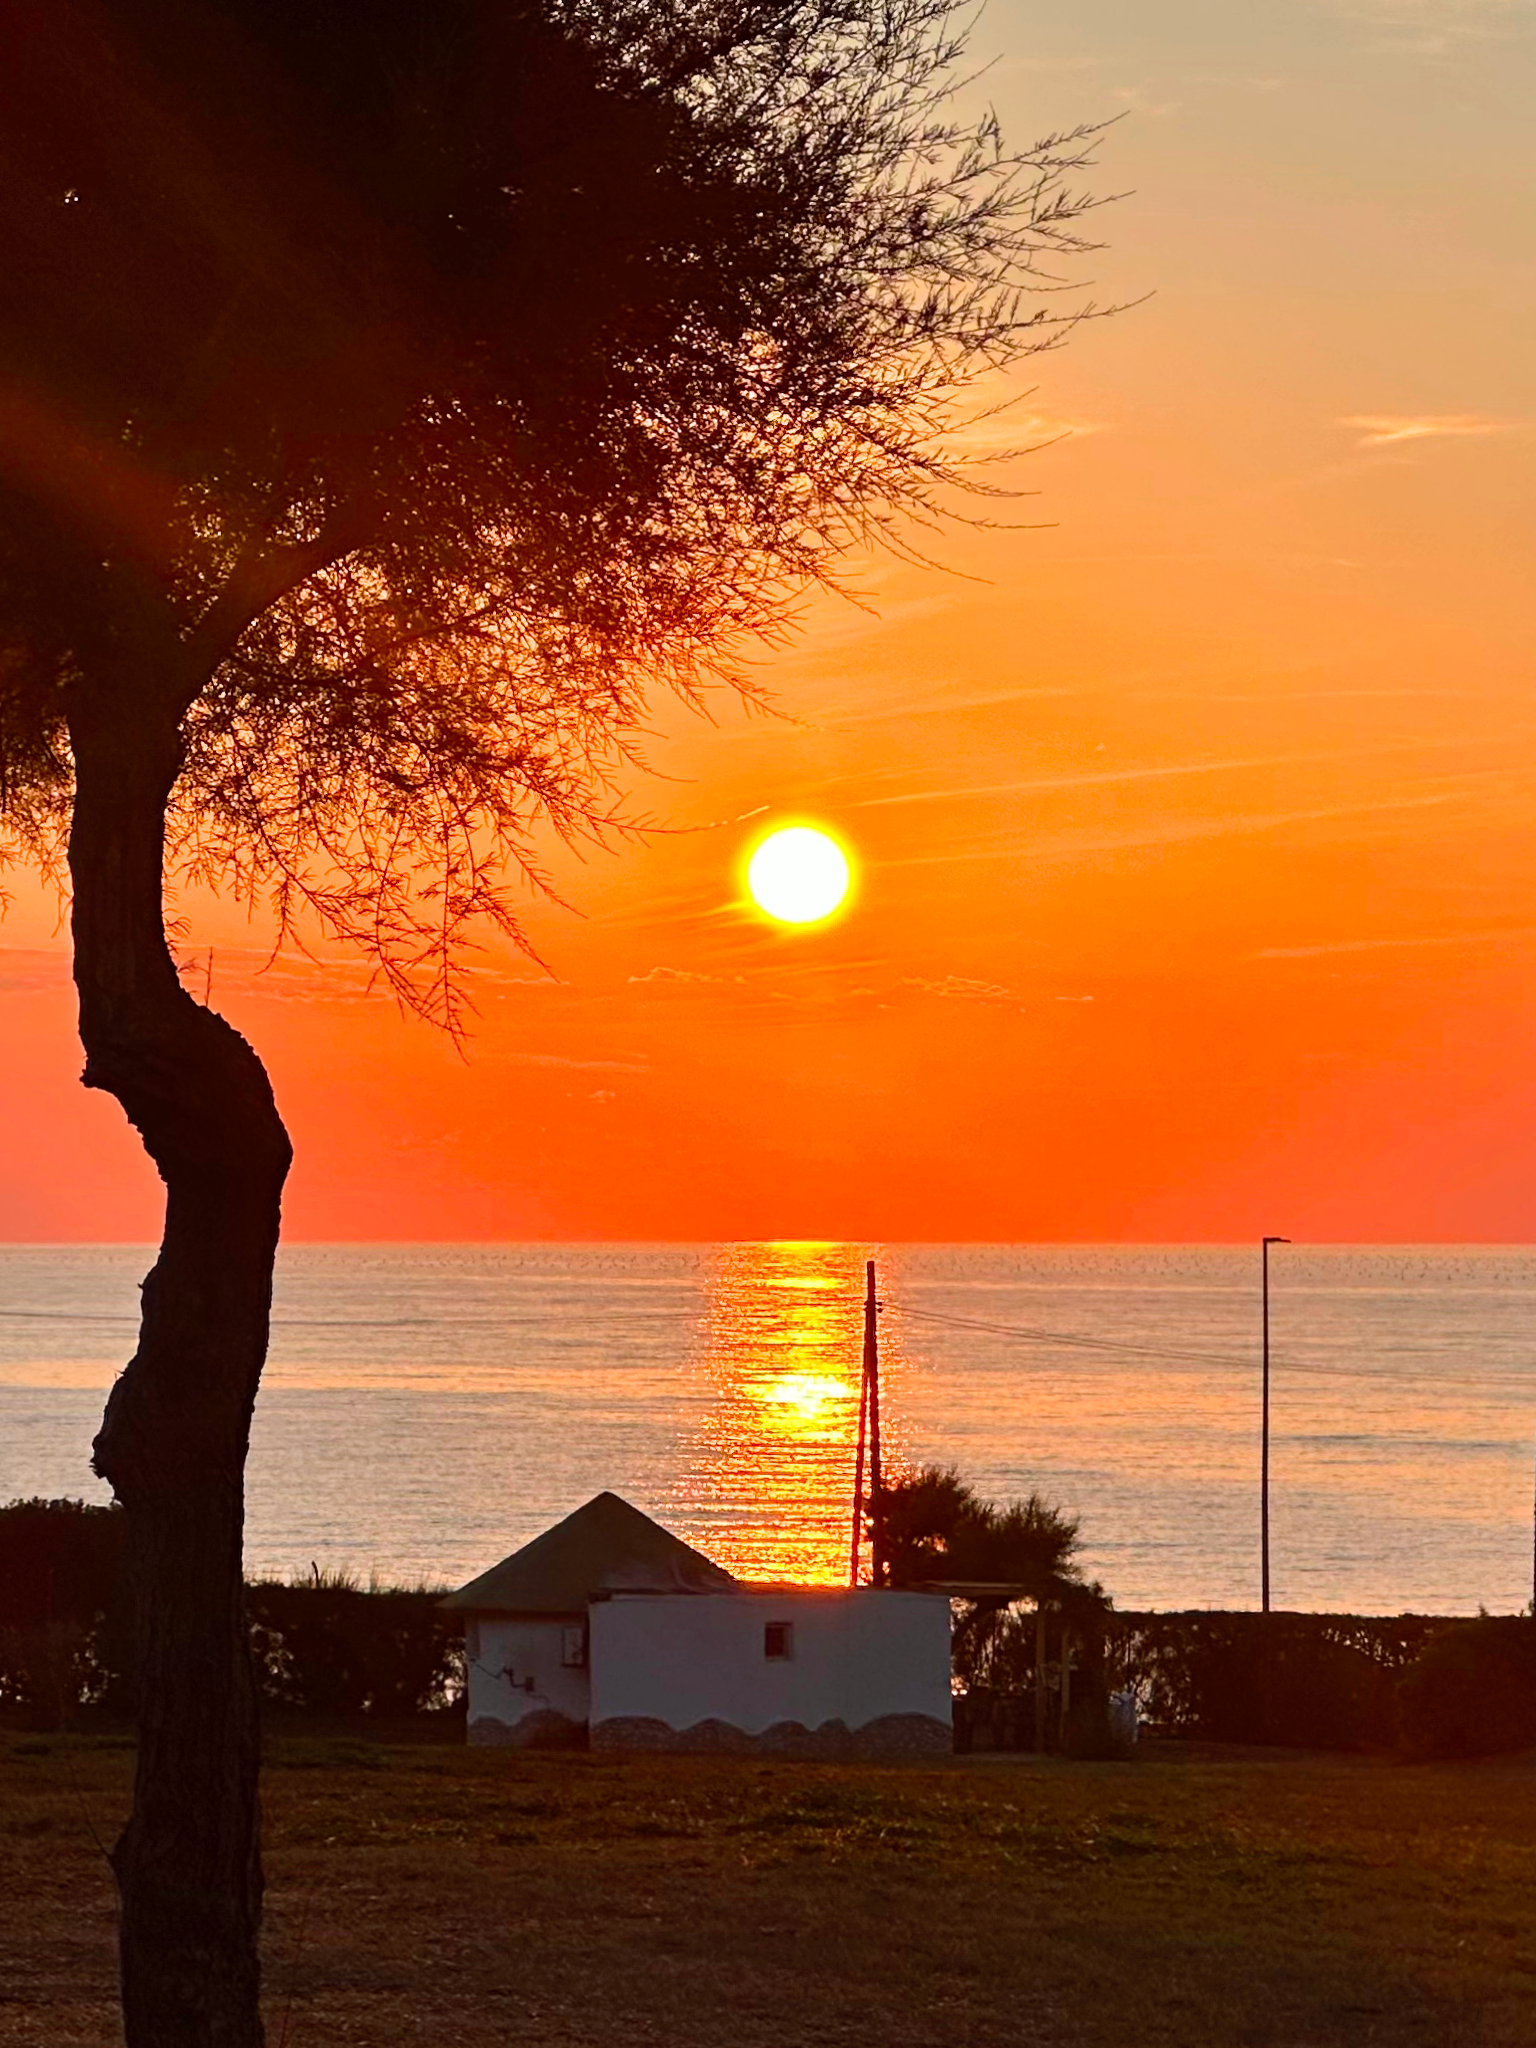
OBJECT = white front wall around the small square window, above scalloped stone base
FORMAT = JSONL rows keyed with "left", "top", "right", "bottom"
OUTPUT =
{"left": 590, "top": 1589, "right": 950, "bottom": 1735}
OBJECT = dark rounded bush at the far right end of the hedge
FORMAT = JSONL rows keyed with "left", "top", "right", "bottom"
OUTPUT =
{"left": 1399, "top": 1614, "right": 1536, "bottom": 1757}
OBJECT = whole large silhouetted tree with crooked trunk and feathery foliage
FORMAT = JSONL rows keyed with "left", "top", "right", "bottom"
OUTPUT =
{"left": 0, "top": 0, "right": 1085, "bottom": 2048}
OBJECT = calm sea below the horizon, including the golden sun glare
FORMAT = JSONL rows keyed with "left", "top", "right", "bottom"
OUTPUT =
{"left": 0, "top": 1243, "right": 1536, "bottom": 1614}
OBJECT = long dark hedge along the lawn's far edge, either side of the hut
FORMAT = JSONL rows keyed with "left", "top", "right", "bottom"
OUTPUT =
{"left": 0, "top": 1501, "right": 1536, "bottom": 1757}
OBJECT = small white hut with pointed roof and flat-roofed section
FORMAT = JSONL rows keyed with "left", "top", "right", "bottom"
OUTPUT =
{"left": 444, "top": 1493, "right": 952, "bottom": 1757}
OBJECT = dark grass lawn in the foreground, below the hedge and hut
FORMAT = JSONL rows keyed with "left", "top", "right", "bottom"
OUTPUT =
{"left": 0, "top": 1737, "right": 1536, "bottom": 2048}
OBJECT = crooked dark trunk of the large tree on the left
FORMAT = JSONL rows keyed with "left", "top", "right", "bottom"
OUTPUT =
{"left": 70, "top": 675, "right": 291, "bottom": 2048}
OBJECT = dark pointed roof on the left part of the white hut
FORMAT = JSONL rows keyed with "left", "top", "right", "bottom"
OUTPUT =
{"left": 442, "top": 1493, "right": 735, "bottom": 1614}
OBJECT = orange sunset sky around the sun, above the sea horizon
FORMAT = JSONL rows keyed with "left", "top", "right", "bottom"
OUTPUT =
{"left": 0, "top": 0, "right": 1536, "bottom": 1239}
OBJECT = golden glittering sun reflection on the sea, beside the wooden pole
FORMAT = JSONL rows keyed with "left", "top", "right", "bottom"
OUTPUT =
{"left": 676, "top": 1241, "right": 903, "bottom": 1585}
